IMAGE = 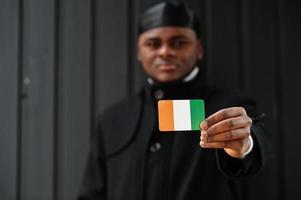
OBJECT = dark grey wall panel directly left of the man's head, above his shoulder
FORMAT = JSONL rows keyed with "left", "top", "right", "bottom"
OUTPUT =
{"left": 95, "top": 0, "right": 129, "bottom": 112}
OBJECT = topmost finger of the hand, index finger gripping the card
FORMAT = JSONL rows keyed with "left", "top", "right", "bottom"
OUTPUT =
{"left": 200, "top": 107, "right": 246, "bottom": 130}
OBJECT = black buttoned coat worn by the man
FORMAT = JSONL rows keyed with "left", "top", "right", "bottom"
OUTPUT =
{"left": 79, "top": 74, "right": 266, "bottom": 200}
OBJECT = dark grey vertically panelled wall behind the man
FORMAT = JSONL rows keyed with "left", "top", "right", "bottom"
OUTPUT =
{"left": 0, "top": 0, "right": 301, "bottom": 200}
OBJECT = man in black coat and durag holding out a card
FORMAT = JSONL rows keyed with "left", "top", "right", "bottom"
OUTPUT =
{"left": 79, "top": 3, "right": 265, "bottom": 200}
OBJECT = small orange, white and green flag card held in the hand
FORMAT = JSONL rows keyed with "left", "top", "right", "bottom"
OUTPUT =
{"left": 158, "top": 99, "right": 205, "bottom": 131}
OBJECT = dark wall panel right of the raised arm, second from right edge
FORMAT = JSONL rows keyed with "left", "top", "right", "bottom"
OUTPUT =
{"left": 241, "top": 0, "right": 282, "bottom": 200}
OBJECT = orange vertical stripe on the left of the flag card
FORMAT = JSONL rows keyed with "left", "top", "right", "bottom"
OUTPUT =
{"left": 158, "top": 100, "right": 174, "bottom": 131}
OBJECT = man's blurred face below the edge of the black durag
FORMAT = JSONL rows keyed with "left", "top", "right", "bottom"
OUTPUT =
{"left": 138, "top": 27, "right": 203, "bottom": 82}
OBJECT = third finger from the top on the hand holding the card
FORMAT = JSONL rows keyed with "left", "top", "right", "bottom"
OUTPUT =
{"left": 202, "top": 128, "right": 251, "bottom": 143}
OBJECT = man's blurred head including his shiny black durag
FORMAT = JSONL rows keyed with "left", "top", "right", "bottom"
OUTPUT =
{"left": 137, "top": 2, "right": 203, "bottom": 83}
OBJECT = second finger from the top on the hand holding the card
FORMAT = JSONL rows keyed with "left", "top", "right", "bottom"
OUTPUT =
{"left": 207, "top": 116, "right": 252, "bottom": 136}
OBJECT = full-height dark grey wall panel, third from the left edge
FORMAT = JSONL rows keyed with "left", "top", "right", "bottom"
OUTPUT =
{"left": 54, "top": 0, "right": 94, "bottom": 200}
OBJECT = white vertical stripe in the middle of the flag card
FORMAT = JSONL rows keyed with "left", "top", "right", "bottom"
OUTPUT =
{"left": 173, "top": 100, "right": 191, "bottom": 131}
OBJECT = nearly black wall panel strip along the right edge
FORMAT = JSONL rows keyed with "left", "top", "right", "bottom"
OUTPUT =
{"left": 277, "top": 0, "right": 301, "bottom": 200}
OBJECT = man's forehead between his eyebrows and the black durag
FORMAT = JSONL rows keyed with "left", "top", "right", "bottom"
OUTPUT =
{"left": 139, "top": 27, "right": 197, "bottom": 40}
